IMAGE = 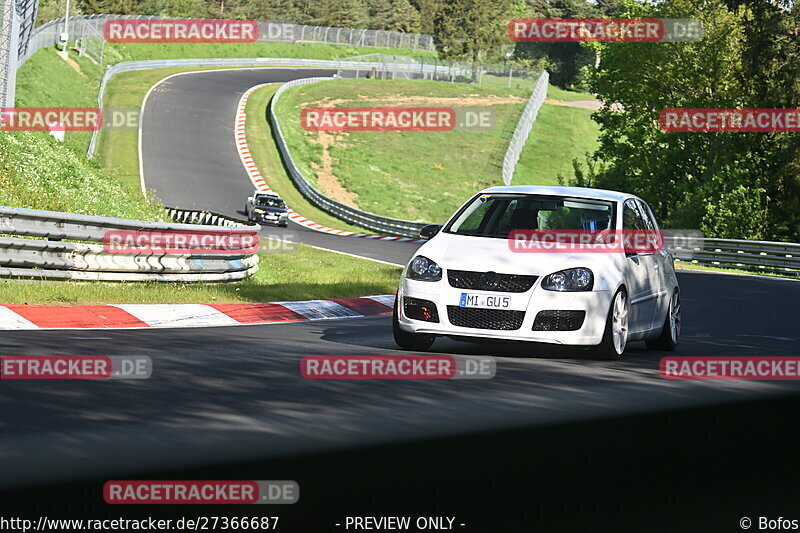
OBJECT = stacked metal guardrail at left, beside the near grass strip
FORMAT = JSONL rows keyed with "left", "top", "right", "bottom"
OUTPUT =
{"left": 0, "top": 207, "right": 260, "bottom": 282}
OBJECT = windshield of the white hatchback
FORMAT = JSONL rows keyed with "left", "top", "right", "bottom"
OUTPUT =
{"left": 445, "top": 194, "right": 615, "bottom": 238}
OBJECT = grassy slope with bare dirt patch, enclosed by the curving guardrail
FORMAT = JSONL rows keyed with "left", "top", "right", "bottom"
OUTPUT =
{"left": 276, "top": 79, "right": 530, "bottom": 222}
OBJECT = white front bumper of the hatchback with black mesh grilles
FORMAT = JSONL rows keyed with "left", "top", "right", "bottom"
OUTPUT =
{"left": 397, "top": 277, "right": 613, "bottom": 346}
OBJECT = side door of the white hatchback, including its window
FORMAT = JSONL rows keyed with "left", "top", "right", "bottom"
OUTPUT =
{"left": 622, "top": 199, "right": 660, "bottom": 333}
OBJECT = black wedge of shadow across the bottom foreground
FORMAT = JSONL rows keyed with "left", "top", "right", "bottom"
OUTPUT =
{"left": 0, "top": 396, "right": 800, "bottom": 533}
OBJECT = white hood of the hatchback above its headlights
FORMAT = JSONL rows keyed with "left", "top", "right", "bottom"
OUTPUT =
{"left": 417, "top": 233, "right": 614, "bottom": 276}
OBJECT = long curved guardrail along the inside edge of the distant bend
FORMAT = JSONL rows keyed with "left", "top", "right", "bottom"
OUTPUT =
{"left": 269, "top": 78, "right": 426, "bottom": 238}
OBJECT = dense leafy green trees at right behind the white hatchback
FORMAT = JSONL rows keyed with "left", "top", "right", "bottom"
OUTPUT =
{"left": 575, "top": 0, "right": 800, "bottom": 239}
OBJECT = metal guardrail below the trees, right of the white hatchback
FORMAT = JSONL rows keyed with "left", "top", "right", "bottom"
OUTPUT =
{"left": 670, "top": 238, "right": 800, "bottom": 275}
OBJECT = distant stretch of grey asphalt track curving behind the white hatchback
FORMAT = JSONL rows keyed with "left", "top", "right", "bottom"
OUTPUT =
{"left": 141, "top": 68, "right": 418, "bottom": 264}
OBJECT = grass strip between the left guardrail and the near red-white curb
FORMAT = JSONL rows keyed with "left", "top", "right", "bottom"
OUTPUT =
{"left": 0, "top": 245, "right": 401, "bottom": 305}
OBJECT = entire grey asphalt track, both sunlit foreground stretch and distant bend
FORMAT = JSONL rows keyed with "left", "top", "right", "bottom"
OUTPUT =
{"left": 0, "top": 69, "right": 800, "bottom": 528}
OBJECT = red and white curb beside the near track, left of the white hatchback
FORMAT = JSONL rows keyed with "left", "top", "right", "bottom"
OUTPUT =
{"left": 0, "top": 294, "right": 395, "bottom": 330}
